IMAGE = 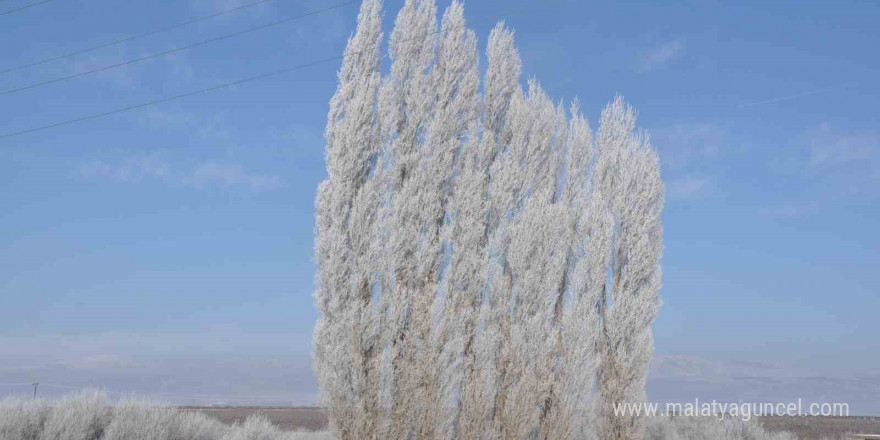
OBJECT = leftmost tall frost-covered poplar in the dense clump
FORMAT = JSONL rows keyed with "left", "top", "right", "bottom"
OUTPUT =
{"left": 314, "top": 1, "right": 382, "bottom": 439}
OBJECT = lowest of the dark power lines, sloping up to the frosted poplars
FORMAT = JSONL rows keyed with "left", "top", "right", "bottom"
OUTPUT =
{"left": 0, "top": 7, "right": 524, "bottom": 139}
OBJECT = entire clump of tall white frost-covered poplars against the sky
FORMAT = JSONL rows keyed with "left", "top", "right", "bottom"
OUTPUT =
{"left": 314, "top": 0, "right": 663, "bottom": 440}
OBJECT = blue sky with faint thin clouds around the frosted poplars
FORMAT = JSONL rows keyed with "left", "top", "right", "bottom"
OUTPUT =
{"left": 0, "top": 0, "right": 880, "bottom": 406}
